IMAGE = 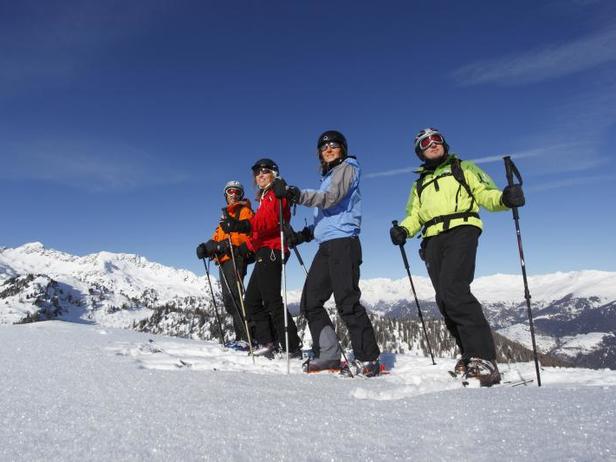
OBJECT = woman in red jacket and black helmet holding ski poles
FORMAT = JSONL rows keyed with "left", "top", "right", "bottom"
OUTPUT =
{"left": 220, "top": 159, "right": 301, "bottom": 358}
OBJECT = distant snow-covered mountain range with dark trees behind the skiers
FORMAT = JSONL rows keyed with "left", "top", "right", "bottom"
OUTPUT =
{"left": 0, "top": 242, "right": 616, "bottom": 368}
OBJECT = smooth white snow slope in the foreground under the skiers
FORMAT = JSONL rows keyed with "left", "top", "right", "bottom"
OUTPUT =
{"left": 0, "top": 321, "right": 616, "bottom": 461}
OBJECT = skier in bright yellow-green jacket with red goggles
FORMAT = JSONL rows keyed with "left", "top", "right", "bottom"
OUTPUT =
{"left": 390, "top": 128, "right": 525, "bottom": 386}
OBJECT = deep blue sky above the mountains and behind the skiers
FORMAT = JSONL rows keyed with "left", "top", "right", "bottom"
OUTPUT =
{"left": 0, "top": 0, "right": 616, "bottom": 287}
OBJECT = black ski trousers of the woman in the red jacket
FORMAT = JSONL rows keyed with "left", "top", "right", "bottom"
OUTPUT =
{"left": 245, "top": 247, "right": 301, "bottom": 353}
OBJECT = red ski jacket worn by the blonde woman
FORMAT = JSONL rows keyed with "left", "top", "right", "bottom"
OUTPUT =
{"left": 247, "top": 188, "right": 291, "bottom": 252}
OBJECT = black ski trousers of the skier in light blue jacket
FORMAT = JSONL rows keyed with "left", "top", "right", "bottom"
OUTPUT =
{"left": 301, "top": 237, "right": 380, "bottom": 361}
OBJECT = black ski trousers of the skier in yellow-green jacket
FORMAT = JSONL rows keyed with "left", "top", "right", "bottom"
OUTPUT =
{"left": 422, "top": 225, "right": 496, "bottom": 360}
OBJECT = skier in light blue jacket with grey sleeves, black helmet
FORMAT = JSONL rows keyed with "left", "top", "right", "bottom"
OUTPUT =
{"left": 285, "top": 130, "right": 380, "bottom": 377}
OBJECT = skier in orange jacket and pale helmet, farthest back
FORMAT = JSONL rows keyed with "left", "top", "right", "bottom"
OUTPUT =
{"left": 197, "top": 180, "right": 254, "bottom": 348}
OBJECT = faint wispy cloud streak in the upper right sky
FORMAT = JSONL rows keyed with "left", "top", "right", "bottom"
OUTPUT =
{"left": 453, "top": 27, "right": 616, "bottom": 85}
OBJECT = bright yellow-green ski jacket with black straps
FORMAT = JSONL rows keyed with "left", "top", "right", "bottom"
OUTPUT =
{"left": 400, "top": 154, "right": 508, "bottom": 237}
